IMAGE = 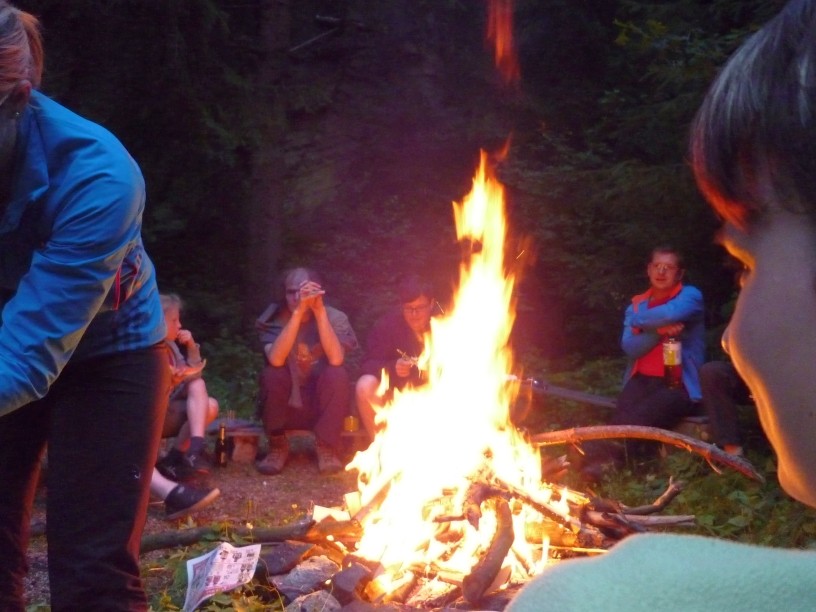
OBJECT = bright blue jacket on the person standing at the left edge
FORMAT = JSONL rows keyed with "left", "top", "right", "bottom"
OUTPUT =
{"left": 0, "top": 91, "right": 165, "bottom": 415}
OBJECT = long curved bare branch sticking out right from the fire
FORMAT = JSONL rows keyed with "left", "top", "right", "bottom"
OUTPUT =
{"left": 530, "top": 425, "right": 765, "bottom": 482}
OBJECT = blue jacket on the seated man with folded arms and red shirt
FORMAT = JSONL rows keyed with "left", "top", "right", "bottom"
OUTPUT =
{"left": 621, "top": 285, "right": 705, "bottom": 402}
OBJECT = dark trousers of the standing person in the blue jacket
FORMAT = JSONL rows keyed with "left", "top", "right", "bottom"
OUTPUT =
{"left": 0, "top": 346, "right": 169, "bottom": 612}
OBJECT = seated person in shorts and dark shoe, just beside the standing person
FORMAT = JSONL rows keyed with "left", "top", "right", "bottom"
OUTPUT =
{"left": 156, "top": 294, "right": 218, "bottom": 481}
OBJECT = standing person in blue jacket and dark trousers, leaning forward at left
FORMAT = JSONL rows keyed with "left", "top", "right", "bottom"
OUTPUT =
{"left": 0, "top": 0, "right": 169, "bottom": 611}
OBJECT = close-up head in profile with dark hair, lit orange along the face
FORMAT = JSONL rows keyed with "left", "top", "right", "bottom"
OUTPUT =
{"left": 691, "top": 0, "right": 816, "bottom": 506}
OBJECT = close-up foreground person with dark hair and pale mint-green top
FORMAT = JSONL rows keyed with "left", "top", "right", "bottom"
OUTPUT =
{"left": 506, "top": 0, "right": 816, "bottom": 612}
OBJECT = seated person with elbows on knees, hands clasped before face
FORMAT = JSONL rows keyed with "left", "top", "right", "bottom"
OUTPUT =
{"left": 255, "top": 268, "right": 357, "bottom": 475}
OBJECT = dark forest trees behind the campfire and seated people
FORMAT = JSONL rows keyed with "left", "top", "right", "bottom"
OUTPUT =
{"left": 17, "top": 0, "right": 781, "bottom": 412}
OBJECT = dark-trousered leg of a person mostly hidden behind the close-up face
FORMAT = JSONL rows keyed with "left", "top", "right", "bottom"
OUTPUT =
{"left": 700, "top": 361, "right": 750, "bottom": 455}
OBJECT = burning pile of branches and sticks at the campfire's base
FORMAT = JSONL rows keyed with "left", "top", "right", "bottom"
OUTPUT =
{"left": 142, "top": 427, "right": 761, "bottom": 607}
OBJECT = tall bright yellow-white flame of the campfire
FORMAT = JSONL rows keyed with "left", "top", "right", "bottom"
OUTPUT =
{"left": 348, "top": 153, "right": 542, "bottom": 590}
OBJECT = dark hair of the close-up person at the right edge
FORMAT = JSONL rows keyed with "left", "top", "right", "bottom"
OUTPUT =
{"left": 690, "top": 0, "right": 816, "bottom": 229}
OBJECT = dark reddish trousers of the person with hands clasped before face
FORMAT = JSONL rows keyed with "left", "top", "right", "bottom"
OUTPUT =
{"left": 259, "top": 365, "right": 351, "bottom": 449}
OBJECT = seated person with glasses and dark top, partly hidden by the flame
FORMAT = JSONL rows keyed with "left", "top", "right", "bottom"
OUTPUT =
{"left": 355, "top": 275, "right": 435, "bottom": 438}
